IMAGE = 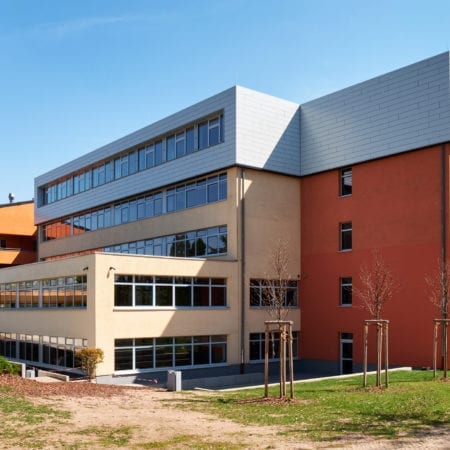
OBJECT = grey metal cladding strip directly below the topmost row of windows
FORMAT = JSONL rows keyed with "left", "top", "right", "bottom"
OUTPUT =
{"left": 35, "top": 142, "right": 235, "bottom": 224}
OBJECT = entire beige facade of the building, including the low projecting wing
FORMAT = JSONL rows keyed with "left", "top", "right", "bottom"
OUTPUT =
{"left": 0, "top": 167, "right": 300, "bottom": 377}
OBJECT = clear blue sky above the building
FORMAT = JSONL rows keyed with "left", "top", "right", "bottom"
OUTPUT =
{"left": 0, "top": 0, "right": 450, "bottom": 203}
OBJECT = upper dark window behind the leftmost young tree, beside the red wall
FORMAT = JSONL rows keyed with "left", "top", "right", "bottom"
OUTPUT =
{"left": 250, "top": 279, "right": 298, "bottom": 308}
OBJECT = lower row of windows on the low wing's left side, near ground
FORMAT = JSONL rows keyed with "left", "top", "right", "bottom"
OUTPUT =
{"left": 0, "top": 333, "right": 87, "bottom": 368}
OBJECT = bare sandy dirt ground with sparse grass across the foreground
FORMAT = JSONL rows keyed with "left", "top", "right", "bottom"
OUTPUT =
{"left": 0, "top": 376, "right": 450, "bottom": 450}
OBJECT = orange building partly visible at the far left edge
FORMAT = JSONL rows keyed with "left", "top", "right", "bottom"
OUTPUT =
{"left": 0, "top": 201, "right": 37, "bottom": 268}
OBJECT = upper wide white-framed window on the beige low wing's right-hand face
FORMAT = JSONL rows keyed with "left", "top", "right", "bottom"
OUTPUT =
{"left": 114, "top": 275, "right": 227, "bottom": 308}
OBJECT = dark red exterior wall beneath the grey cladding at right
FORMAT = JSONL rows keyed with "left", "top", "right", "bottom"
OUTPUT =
{"left": 300, "top": 144, "right": 450, "bottom": 367}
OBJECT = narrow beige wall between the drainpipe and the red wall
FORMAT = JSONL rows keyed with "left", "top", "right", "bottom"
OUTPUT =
{"left": 244, "top": 170, "right": 301, "bottom": 350}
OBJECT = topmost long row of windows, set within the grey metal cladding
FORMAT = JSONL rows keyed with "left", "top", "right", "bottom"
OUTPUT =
{"left": 42, "top": 114, "right": 224, "bottom": 205}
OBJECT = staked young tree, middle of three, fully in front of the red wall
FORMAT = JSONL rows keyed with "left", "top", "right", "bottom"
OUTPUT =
{"left": 353, "top": 251, "right": 399, "bottom": 386}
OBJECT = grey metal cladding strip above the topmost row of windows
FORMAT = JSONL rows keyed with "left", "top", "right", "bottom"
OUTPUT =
{"left": 35, "top": 87, "right": 236, "bottom": 188}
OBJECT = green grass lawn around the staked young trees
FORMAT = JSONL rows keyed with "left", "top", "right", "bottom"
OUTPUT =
{"left": 181, "top": 371, "right": 450, "bottom": 440}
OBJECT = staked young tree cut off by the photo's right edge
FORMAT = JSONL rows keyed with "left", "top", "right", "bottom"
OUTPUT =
{"left": 425, "top": 258, "right": 450, "bottom": 378}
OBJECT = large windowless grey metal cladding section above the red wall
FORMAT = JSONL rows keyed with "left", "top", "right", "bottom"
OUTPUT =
{"left": 300, "top": 52, "right": 450, "bottom": 175}
